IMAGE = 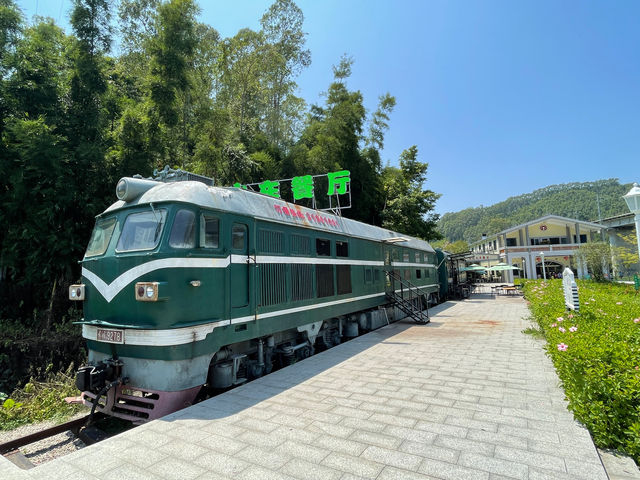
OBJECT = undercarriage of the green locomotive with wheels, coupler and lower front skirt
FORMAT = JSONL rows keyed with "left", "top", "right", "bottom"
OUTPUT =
{"left": 76, "top": 309, "right": 402, "bottom": 423}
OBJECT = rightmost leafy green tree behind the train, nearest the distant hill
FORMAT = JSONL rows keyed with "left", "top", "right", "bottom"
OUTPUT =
{"left": 382, "top": 145, "right": 440, "bottom": 240}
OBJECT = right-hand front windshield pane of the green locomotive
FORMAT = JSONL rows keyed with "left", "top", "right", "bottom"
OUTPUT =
{"left": 116, "top": 210, "right": 167, "bottom": 252}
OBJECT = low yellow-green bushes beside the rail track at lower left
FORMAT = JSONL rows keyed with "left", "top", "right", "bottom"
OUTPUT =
{"left": 0, "top": 365, "right": 85, "bottom": 430}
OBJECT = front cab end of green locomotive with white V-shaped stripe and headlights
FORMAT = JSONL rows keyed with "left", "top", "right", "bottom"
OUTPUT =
{"left": 69, "top": 178, "right": 225, "bottom": 422}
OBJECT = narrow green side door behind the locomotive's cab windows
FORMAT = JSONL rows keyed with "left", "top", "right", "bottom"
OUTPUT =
{"left": 229, "top": 222, "right": 249, "bottom": 317}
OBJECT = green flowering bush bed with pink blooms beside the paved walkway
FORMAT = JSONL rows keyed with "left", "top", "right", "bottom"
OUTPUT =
{"left": 524, "top": 280, "right": 640, "bottom": 462}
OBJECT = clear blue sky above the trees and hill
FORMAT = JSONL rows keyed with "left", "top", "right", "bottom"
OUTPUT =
{"left": 18, "top": 0, "right": 640, "bottom": 214}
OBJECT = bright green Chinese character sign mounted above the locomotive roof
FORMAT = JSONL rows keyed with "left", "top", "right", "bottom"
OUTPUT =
{"left": 233, "top": 170, "right": 351, "bottom": 208}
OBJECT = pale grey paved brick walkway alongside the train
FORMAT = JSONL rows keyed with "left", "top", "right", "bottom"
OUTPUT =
{"left": 0, "top": 295, "right": 607, "bottom": 480}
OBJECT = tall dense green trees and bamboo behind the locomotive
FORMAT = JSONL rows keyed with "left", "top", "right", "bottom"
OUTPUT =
{"left": 0, "top": 0, "right": 439, "bottom": 391}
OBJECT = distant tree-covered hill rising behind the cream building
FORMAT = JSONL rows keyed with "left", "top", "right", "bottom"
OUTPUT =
{"left": 438, "top": 178, "right": 631, "bottom": 242}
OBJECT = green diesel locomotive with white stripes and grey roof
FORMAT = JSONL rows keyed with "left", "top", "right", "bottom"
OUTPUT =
{"left": 69, "top": 172, "right": 439, "bottom": 422}
